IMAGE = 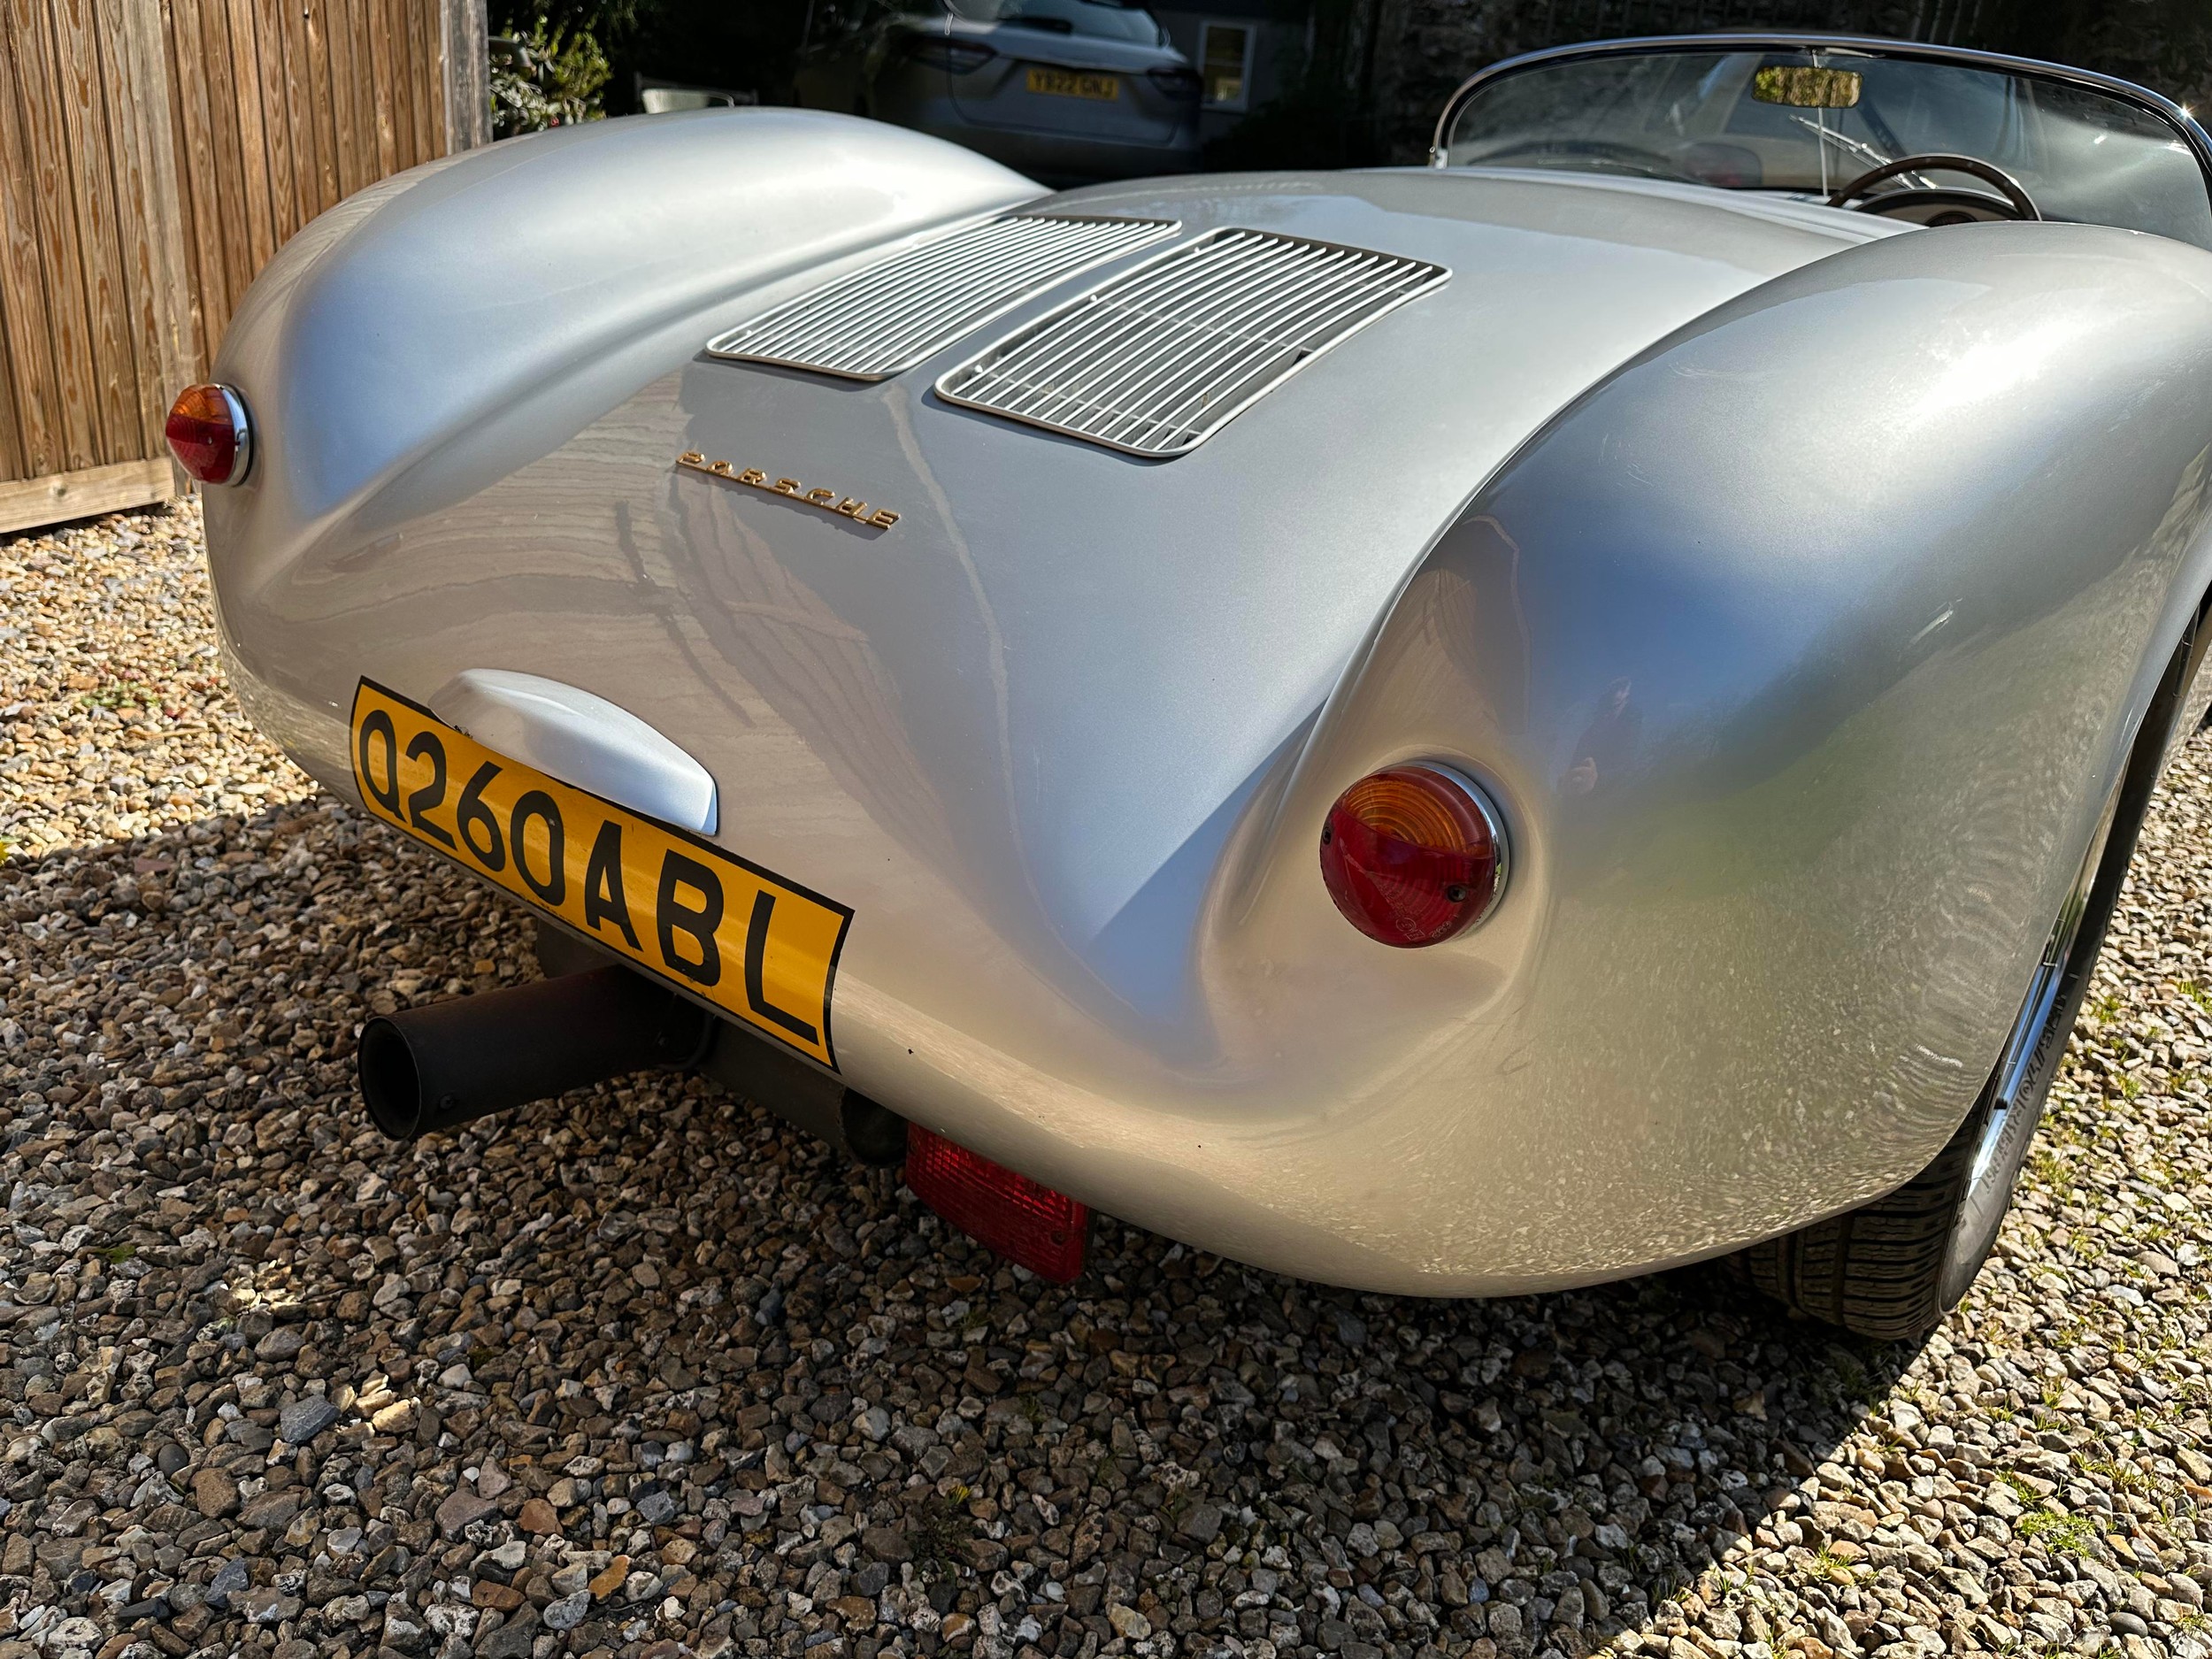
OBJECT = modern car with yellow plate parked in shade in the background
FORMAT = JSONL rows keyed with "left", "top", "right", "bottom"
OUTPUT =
{"left": 799, "top": 0, "right": 1203, "bottom": 181}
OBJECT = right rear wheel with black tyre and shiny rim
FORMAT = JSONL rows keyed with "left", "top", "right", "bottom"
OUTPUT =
{"left": 1737, "top": 622, "right": 2206, "bottom": 1340}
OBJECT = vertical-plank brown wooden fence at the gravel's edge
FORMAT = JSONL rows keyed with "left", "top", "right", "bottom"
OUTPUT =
{"left": 0, "top": 0, "right": 489, "bottom": 531}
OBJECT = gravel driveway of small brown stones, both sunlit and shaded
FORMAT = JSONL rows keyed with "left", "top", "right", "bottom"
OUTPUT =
{"left": 0, "top": 507, "right": 2212, "bottom": 1659}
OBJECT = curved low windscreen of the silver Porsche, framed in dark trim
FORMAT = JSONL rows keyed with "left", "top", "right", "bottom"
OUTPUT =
{"left": 1445, "top": 51, "right": 2212, "bottom": 248}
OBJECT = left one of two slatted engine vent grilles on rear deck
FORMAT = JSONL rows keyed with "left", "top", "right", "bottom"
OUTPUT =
{"left": 706, "top": 212, "right": 1177, "bottom": 380}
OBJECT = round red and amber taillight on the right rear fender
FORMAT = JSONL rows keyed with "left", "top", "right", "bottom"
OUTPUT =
{"left": 1321, "top": 765, "right": 1507, "bottom": 945}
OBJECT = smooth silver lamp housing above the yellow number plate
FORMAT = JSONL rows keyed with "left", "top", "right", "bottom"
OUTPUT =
{"left": 429, "top": 668, "right": 721, "bottom": 836}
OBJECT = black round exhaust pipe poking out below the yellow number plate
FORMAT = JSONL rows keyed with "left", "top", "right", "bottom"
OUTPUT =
{"left": 358, "top": 967, "right": 715, "bottom": 1141}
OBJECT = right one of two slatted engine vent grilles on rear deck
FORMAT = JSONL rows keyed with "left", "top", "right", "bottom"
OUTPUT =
{"left": 938, "top": 230, "right": 1451, "bottom": 456}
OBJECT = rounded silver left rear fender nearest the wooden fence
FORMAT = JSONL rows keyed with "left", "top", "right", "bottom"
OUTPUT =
{"left": 208, "top": 109, "right": 1042, "bottom": 582}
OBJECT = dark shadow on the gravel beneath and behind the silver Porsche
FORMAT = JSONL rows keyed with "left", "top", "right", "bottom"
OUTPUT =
{"left": 0, "top": 796, "right": 1978, "bottom": 1659}
